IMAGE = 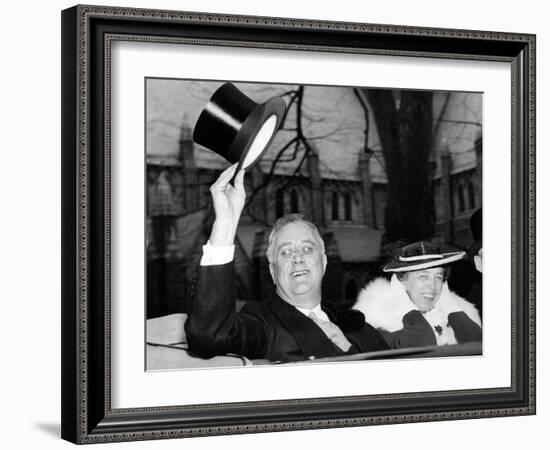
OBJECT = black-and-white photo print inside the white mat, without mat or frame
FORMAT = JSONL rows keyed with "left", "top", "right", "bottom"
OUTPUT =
{"left": 148, "top": 78, "right": 484, "bottom": 370}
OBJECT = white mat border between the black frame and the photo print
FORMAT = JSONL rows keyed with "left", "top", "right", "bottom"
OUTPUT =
{"left": 111, "top": 42, "right": 511, "bottom": 408}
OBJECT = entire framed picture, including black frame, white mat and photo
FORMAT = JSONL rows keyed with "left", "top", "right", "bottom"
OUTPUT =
{"left": 60, "top": 1, "right": 536, "bottom": 447}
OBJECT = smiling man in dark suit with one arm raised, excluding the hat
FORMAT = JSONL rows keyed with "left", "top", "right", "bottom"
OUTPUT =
{"left": 185, "top": 166, "right": 388, "bottom": 361}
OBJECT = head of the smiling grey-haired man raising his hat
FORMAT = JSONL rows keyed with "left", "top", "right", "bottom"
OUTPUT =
{"left": 269, "top": 222, "right": 327, "bottom": 308}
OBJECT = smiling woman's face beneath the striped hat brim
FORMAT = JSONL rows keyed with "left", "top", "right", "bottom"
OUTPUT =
{"left": 401, "top": 267, "right": 445, "bottom": 312}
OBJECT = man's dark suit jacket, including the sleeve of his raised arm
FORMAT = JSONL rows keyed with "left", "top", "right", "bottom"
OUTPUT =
{"left": 185, "top": 262, "right": 388, "bottom": 361}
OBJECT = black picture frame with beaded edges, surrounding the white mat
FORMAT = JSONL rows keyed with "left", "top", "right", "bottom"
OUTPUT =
{"left": 62, "top": 5, "right": 535, "bottom": 444}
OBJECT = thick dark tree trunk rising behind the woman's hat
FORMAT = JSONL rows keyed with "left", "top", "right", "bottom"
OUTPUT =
{"left": 363, "top": 89, "right": 435, "bottom": 242}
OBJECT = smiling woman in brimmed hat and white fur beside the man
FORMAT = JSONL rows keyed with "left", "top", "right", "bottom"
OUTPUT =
{"left": 354, "top": 242, "right": 481, "bottom": 348}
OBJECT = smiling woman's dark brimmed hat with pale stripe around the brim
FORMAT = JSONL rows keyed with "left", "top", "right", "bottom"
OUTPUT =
{"left": 382, "top": 242, "right": 466, "bottom": 272}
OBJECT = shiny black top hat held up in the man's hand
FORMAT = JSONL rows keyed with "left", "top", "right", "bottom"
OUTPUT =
{"left": 193, "top": 83, "right": 286, "bottom": 174}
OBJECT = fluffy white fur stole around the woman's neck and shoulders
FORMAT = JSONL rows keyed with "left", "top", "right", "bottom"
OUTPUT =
{"left": 353, "top": 275, "right": 481, "bottom": 345}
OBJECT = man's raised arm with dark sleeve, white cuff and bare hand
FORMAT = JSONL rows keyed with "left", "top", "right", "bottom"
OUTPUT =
{"left": 185, "top": 165, "right": 266, "bottom": 358}
